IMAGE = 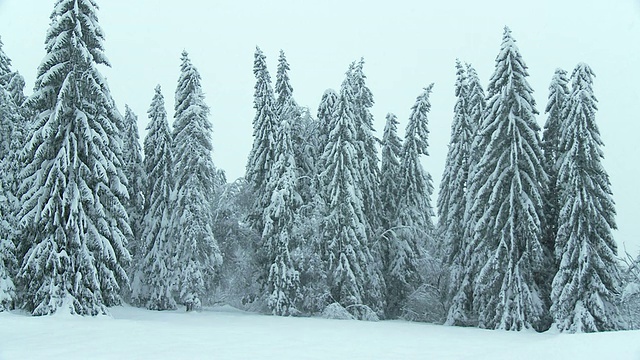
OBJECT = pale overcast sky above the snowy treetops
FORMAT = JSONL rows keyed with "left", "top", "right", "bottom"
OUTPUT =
{"left": 0, "top": 0, "right": 640, "bottom": 254}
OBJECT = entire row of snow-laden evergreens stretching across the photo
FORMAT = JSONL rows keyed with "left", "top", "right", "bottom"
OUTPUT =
{"left": 0, "top": 0, "right": 622, "bottom": 331}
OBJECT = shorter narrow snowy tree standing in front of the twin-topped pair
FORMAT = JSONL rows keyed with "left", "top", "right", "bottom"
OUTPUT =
{"left": 262, "top": 98, "right": 302, "bottom": 316}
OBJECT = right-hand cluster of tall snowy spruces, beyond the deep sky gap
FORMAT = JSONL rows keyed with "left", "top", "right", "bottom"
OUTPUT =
{"left": 438, "top": 29, "right": 621, "bottom": 331}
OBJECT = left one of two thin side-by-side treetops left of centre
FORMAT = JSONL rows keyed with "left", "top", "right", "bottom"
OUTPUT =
{"left": 245, "top": 47, "right": 278, "bottom": 234}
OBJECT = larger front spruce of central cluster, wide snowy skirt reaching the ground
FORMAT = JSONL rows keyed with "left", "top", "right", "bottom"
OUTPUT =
{"left": 320, "top": 69, "right": 384, "bottom": 318}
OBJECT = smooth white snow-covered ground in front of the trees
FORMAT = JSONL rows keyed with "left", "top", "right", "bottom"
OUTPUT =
{"left": 0, "top": 307, "right": 640, "bottom": 360}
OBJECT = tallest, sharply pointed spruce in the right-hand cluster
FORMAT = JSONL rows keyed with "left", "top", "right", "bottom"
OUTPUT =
{"left": 471, "top": 27, "right": 547, "bottom": 330}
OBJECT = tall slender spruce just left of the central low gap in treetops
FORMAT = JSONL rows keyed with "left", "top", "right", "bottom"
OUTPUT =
{"left": 171, "top": 51, "right": 222, "bottom": 311}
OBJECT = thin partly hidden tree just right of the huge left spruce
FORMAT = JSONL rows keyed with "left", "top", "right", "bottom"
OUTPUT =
{"left": 122, "top": 105, "right": 146, "bottom": 264}
